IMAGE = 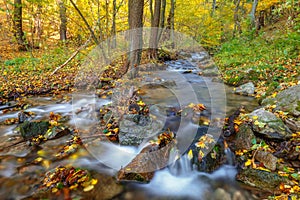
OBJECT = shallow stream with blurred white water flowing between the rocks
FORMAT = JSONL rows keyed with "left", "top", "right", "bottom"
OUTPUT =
{"left": 0, "top": 52, "right": 258, "bottom": 200}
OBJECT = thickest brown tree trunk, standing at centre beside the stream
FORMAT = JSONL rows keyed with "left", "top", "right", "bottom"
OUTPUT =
{"left": 128, "top": 0, "right": 144, "bottom": 78}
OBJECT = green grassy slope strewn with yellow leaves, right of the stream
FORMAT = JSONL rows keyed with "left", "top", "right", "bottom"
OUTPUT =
{"left": 214, "top": 21, "right": 300, "bottom": 98}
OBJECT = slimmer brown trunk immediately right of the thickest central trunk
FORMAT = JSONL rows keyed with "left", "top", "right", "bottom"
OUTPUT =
{"left": 149, "top": 0, "right": 161, "bottom": 59}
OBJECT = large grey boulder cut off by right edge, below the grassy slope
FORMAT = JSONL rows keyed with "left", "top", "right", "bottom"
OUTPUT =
{"left": 262, "top": 85, "right": 300, "bottom": 117}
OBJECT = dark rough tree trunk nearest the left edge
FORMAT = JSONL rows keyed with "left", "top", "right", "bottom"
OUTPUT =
{"left": 13, "top": 0, "right": 27, "bottom": 51}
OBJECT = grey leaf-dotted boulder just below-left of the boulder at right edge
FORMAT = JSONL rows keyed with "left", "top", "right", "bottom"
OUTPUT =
{"left": 249, "top": 108, "right": 292, "bottom": 140}
